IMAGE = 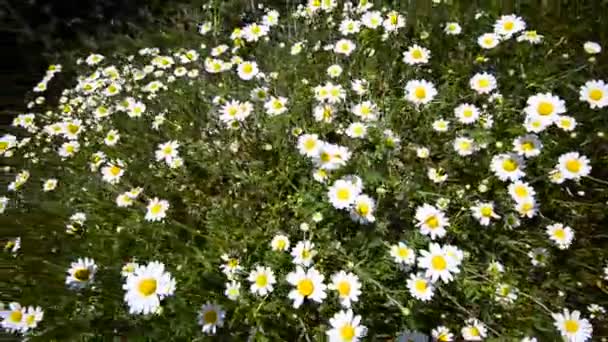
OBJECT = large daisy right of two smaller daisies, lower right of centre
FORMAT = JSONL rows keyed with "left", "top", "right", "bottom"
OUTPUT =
{"left": 418, "top": 243, "right": 460, "bottom": 283}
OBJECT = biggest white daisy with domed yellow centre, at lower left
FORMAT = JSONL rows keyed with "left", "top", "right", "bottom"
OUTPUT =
{"left": 123, "top": 261, "right": 175, "bottom": 315}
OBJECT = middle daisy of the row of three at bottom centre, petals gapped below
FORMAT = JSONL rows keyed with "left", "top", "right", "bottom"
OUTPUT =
{"left": 286, "top": 266, "right": 327, "bottom": 309}
